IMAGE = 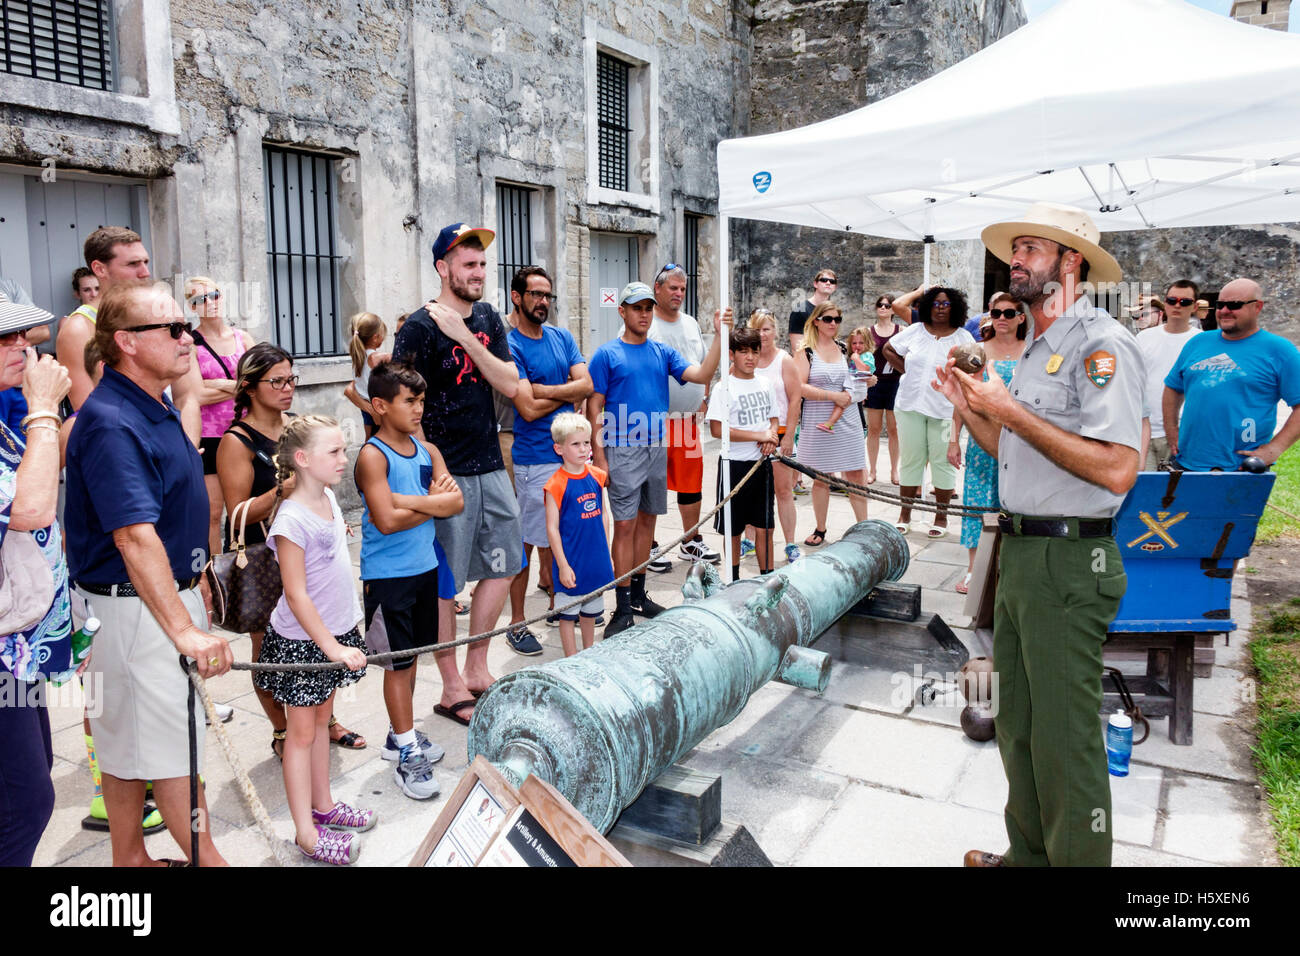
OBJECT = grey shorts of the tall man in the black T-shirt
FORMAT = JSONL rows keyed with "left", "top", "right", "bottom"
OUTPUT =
{"left": 436, "top": 468, "right": 524, "bottom": 592}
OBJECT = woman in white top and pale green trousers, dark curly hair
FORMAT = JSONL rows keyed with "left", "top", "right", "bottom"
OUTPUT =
{"left": 884, "top": 286, "right": 975, "bottom": 537}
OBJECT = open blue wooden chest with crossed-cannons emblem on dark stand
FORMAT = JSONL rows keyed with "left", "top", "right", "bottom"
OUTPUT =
{"left": 1106, "top": 472, "right": 1275, "bottom": 744}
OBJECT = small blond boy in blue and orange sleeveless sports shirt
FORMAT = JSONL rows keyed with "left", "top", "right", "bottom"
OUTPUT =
{"left": 543, "top": 412, "right": 614, "bottom": 657}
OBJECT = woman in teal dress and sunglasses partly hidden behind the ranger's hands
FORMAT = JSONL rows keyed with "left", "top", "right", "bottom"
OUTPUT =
{"left": 948, "top": 293, "right": 1030, "bottom": 594}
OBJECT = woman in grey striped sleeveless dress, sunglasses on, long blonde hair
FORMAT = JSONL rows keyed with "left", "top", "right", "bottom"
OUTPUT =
{"left": 794, "top": 302, "right": 875, "bottom": 548}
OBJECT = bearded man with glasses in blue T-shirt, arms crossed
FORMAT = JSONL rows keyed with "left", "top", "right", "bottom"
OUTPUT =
{"left": 506, "top": 265, "right": 592, "bottom": 653}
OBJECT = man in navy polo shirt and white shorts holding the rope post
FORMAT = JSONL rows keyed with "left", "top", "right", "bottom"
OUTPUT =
{"left": 65, "top": 281, "right": 233, "bottom": 866}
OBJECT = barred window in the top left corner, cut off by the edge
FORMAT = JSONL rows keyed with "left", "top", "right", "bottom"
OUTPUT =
{"left": 0, "top": 0, "right": 113, "bottom": 90}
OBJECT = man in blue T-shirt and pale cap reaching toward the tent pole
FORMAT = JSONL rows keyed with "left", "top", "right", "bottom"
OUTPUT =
{"left": 592, "top": 282, "right": 731, "bottom": 637}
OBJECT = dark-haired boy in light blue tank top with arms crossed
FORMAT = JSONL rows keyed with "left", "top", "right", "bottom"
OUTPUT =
{"left": 354, "top": 362, "right": 472, "bottom": 800}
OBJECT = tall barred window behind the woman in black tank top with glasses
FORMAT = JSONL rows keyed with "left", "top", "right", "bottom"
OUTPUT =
{"left": 263, "top": 146, "right": 345, "bottom": 358}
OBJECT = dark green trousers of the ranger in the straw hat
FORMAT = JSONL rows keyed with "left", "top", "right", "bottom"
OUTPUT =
{"left": 993, "top": 535, "right": 1127, "bottom": 866}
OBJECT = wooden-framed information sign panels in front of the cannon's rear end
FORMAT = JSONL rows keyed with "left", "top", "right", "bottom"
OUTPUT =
{"left": 408, "top": 754, "right": 632, "bottom": 866}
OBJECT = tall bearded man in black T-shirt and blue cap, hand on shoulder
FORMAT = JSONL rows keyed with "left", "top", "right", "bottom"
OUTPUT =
{"left": 393, "top": 222, "right": 523, "bottom": 724}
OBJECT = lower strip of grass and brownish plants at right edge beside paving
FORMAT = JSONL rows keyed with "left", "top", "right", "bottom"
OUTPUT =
{"left": 1251, "top": 597, "right": 1300, "bottom": 866}
